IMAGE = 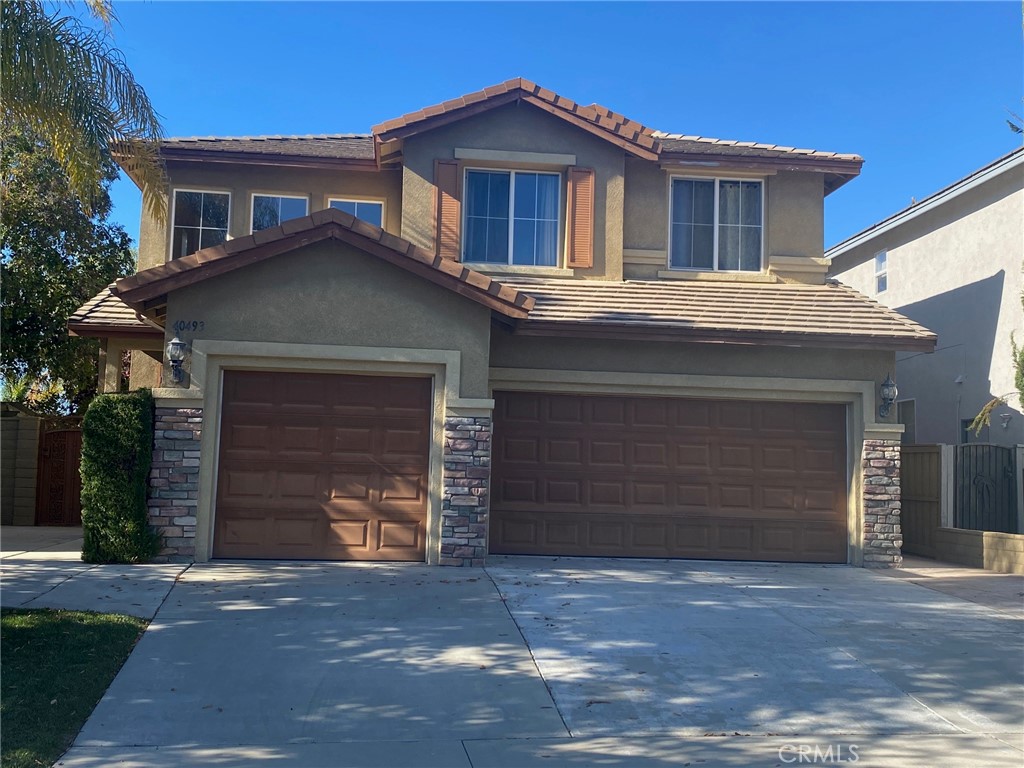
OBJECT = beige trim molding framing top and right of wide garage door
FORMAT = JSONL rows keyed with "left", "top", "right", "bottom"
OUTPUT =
{"left": 489, "top": 368, "right": 888, "bottom": 565}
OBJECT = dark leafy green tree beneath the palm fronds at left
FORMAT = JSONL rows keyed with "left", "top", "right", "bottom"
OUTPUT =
{"left": 0, "top": 134, "right": 134, "bottom": 413}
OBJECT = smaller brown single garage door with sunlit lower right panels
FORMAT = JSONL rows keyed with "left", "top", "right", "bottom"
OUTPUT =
{"left": 213, "top": 371, "right": 431, "bottom": 560}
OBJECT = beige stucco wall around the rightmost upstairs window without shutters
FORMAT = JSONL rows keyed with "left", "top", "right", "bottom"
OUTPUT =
{"left": 623, "top": 158, "right": 824, "bottom": 278}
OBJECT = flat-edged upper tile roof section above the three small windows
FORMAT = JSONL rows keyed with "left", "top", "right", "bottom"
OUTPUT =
{"left": 161, "top": 133, "right": 374, "bottom": 160}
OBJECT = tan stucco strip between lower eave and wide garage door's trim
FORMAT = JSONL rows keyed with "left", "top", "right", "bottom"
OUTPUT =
{"left": 490, "top": 329, "right": 894, "bottom": 403}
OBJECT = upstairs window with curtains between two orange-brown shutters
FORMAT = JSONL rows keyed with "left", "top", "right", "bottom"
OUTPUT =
{"left": 463, "top": 170, "right": 561, "bottom": 266}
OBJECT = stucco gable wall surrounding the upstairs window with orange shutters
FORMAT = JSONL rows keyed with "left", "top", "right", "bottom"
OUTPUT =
{"left": 401, "top": 103, "right": 625, "bottom": 280}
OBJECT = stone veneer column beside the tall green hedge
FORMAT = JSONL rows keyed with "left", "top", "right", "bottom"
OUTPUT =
{"left": 148, "top": 407, "right": 203, "bottom": 562}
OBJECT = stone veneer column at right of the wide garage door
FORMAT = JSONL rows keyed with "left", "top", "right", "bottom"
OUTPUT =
{"left": 861, "top": 440, "right": 903, "bottom": 568}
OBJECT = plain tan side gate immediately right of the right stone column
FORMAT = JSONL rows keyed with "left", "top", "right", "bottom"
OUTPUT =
{"left": 900, "top": 445, "right": 942, "bottom": 557}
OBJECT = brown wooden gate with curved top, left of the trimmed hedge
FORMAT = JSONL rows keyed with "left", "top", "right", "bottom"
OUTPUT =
{"left": 36, "top": 429, "right": 82, "bottom": 525}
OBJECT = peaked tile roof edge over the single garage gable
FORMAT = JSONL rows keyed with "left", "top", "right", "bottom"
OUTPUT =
{"left": 114, "top": 208, "right": 534, "bottom": 318}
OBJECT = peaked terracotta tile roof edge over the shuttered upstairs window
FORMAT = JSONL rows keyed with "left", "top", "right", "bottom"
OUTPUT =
{"left": 373, "top": 78, "right": 658, "bottom": 160}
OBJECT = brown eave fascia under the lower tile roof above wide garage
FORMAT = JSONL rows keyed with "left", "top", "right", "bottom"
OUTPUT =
{"left": 514, "top": 319, "right": 936, "bottom": 352}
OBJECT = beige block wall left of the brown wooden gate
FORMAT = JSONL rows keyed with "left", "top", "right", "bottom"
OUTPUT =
{"left": 0, "top": 404, "right": 41, "bottom": 525}
